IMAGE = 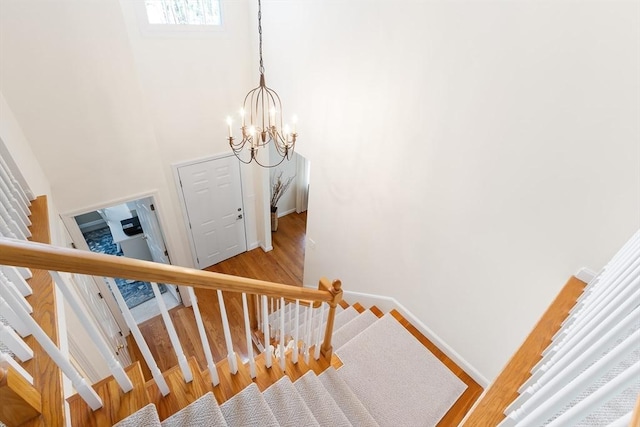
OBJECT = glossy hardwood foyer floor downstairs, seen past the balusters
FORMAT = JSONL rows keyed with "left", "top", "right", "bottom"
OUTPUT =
{"left": 128, "top": 212, "right": 307, "bottom": 378}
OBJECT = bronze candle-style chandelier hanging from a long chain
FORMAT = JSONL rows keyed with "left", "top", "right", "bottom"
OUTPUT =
{"left": 227, "top": 0, "right": 298, "bottom": 168}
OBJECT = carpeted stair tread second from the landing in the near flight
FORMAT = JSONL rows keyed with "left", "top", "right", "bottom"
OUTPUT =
{"left": 293, "top": 371, "right": 352, "bottom": 427}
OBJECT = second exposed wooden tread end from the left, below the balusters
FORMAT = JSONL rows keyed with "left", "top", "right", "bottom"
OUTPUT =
{"left": 146, "top": 357, "right": 213, "bottom": 420}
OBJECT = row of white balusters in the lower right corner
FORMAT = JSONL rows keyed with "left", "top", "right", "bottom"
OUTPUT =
{"left": 500, "top": 231, "right": 640, "bottom": 427}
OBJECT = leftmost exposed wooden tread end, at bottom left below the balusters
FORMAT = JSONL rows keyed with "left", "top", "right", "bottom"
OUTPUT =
{"left": 67, "top": 362, "right": 150, "bottom": 427}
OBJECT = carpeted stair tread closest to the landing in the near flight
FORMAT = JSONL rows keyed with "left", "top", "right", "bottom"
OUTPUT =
{"left": 318, "top": 367, "right": 378, "bottom": 427}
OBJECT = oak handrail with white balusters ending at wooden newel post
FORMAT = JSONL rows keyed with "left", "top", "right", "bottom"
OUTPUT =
{"left": 0, "top": 237, "right": 342, "bottom": 410}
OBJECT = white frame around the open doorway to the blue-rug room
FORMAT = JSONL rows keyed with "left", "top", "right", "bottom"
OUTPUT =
{"left": 60, "top": 191, "right": 178, "bottom": 336}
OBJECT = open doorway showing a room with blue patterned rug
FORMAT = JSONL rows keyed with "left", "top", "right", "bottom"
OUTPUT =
{"left": 73, "top": 196, "right": 181, "bottom": 323}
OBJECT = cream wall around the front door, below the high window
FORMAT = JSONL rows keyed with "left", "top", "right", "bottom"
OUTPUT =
{"left": 0, "top": 0, "right": 257, "bottom": 266}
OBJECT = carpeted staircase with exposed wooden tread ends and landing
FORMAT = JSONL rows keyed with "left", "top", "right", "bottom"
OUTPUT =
{"left": 68, "top": 303, "right": 472, "bottom": 426}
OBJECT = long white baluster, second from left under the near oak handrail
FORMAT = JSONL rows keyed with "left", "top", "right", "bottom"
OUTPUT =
{"left": 49, "top": 271, "right": 133, "bottom": 393}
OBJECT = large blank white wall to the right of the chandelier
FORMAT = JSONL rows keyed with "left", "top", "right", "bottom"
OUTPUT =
{"left": 263, "top": 0, "right": 640, "bottom": 379}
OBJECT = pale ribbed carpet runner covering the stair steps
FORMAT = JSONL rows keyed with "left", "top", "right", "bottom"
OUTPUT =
{"left": 116, "top": 307, "right": 464, "bottom": 427}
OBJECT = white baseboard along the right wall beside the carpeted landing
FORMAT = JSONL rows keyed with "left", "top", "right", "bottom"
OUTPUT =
{"left": 305, "top": 286, "right": 490, "bottom": 389}
